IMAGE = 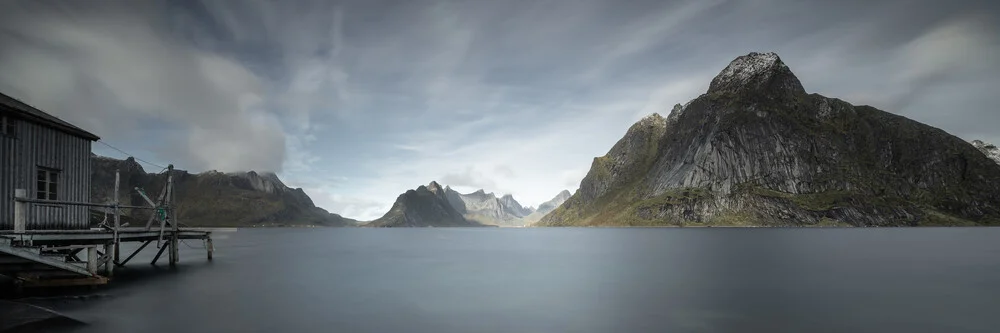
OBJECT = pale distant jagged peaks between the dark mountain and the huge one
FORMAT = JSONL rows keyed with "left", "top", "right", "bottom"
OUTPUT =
{"left": 444, "top": 186, "right": 532, "bottom": 226}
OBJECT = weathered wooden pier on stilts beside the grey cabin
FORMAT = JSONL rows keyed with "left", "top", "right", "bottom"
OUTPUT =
{"left": 0, "top": 165, "right": 227, "bottom": 287}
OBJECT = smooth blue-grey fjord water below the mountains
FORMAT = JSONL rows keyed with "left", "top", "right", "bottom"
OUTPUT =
{"left": 11, "top": 228, "right": 1000, "bottom": 333}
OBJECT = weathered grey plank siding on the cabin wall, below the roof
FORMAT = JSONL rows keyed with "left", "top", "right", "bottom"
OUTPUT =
{"left": 0, "top": 121, "right": 91, "bottom": 230}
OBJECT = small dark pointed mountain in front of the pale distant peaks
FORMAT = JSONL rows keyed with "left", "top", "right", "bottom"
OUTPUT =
{"left": 364, "top": 182, "right": 482, "bottom": 228}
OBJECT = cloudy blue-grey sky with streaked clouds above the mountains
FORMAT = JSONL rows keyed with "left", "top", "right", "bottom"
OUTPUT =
{"left": 0, "top": 0, "right": 1000, "bottom": 220}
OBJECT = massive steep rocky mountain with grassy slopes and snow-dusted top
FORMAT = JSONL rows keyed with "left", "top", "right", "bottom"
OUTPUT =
{"left": 538, "top": 53, "right": 1000, "bottom": 226}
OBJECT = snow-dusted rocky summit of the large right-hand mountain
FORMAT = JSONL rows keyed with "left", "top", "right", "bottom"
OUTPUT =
{"left": 708, "top": 52, "right": 806, "bottom": 97}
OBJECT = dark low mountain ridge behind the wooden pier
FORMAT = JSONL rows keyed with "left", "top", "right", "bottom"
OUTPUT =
{"left": 91, "top": 154, "right": 357, "bottom": 227}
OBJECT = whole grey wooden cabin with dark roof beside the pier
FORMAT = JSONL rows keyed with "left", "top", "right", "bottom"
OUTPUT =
{"left": 0, "top": 93, "right": 100, "bottom": 230}
